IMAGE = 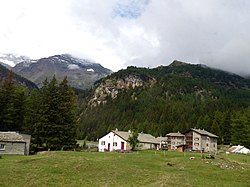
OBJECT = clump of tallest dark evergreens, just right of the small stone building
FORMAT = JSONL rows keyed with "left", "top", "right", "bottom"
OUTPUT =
{"left": 26, "top": 76, "right": 77, "bottom": 149}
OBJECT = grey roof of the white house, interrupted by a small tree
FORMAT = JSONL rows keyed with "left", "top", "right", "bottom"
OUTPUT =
{"left": 112, "top": 130, "right": 159, "bottom": 144}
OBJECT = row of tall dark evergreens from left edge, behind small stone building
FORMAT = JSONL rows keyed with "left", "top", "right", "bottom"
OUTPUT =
{"left": 0, "top": 72, "right": 77, "bottom": 149}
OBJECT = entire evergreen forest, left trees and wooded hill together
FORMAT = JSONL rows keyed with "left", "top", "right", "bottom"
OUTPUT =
{"left": 0, "top": 61, "right": 250, "bottom": 149}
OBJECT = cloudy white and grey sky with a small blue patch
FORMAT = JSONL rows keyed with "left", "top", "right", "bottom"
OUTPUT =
{"left": 0, "top": 0, "right": 250, "bottom": 74}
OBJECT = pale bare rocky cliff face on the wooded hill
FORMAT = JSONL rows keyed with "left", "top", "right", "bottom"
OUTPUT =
{"left": 89, "top": 75, "right": 156, "bottom": 107}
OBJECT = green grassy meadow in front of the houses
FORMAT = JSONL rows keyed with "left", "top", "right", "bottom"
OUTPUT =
{"left": 0, "top": 151, "right": 250, "bottom": 187}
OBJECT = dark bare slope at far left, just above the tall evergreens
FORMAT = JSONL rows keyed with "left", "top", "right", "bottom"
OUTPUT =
{"left": 0, "top": 64, "right": 37, "bottom": 90}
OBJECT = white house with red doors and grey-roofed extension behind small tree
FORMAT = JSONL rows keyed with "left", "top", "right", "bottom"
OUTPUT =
{"left": 98, "top": 130, "right": 159, "bottom": 152}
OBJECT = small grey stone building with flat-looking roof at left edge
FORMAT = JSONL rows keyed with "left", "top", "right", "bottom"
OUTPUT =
{"left": 0, "top": 132, "right": 31, "bottom": 155}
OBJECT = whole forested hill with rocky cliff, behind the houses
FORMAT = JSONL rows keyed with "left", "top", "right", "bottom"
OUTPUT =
{"left": 77, "top": 61, "right": 250, "bottom": 145}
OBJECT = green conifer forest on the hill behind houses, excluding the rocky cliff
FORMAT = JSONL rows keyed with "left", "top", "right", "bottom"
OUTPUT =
{"left": 77, "top": 67, "right": 250, "bottom": 147}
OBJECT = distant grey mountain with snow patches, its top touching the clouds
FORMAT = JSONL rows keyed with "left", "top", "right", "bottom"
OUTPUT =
{"left": 13, "top": 54, "right": 112, "bottom": 89}
